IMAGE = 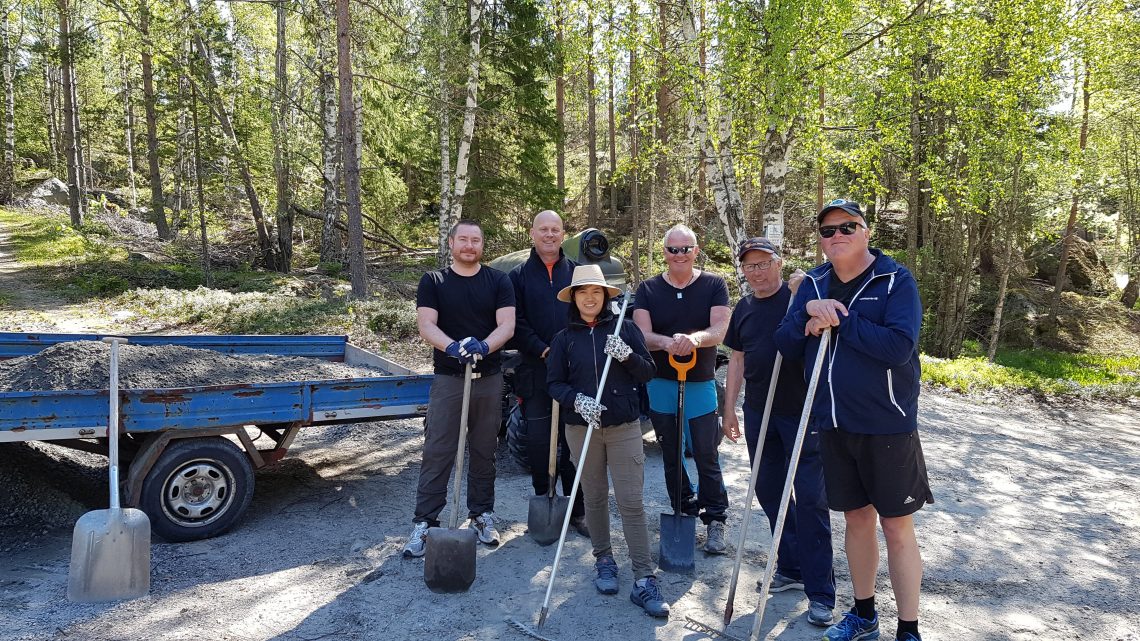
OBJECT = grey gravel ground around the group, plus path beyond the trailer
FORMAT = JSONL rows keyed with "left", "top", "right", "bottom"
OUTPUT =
{"left": 0, "top": 215, "right": 1140, "bottom": 641}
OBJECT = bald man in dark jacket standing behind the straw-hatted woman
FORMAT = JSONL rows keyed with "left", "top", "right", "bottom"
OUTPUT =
{"left": 510, "top": 210, "right": 589, "bottom": 536}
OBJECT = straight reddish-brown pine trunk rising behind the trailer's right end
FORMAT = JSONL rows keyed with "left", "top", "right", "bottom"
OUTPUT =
{"left": 336, "top": 0, "right": 368, "bottom": 299}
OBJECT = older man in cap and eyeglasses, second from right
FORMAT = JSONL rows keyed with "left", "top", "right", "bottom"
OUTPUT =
{"left": 724, "top": 238, "right": 836, "bottom": 626}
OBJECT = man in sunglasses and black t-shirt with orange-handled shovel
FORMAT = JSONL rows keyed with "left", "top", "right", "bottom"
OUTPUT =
{"left": 634, "top": 225, "right": 731, "bottom": 554}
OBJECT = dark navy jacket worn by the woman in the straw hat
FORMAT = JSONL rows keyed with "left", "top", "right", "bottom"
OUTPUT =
{"left": 546, "top": 306, "right": 657, "bottom": 428}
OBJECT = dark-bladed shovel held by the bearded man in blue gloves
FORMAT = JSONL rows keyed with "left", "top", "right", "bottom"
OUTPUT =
{"left": 424, "top": 363, "right": 477, "bottom": 592}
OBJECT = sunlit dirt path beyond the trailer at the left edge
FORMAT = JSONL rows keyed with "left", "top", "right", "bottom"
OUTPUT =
{"left": 0, "top": 218, "right": 119, "bottom": 333}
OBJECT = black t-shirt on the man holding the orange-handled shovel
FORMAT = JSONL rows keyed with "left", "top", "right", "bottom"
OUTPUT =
{"left": 634, "top": 271, "right": 728, "bottom": 382}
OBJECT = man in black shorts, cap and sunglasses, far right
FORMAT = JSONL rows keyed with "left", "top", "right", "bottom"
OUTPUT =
{"left": 776, "top": 198, "right": 934, "bottom": 641}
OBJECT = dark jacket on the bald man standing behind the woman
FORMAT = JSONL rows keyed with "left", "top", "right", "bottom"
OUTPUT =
{"left": 508, "top": 249, "right": 578, "bottom": 360}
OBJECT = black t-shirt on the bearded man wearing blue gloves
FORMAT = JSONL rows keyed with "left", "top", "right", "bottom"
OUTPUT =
{"left": 416, "top": 266, "right": 514, "bottom": 376}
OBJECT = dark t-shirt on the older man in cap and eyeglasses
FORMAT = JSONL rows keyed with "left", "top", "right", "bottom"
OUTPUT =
{"left": 724, "top": 283, "right": 807, "bottom": 416}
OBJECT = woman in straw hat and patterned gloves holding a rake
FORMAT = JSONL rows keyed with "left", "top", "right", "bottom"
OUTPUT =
{"left": 546, "top": 265, "right": 669, "bottom": 617}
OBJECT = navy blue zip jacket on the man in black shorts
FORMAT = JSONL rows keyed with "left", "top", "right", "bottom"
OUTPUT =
{"left": 775, "top": 249, "right": 922, "bottom": 435}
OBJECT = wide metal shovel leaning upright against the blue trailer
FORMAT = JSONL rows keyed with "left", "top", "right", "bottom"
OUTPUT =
{"left": 67, "top": 338, "right": 150, "bottom": 603}
